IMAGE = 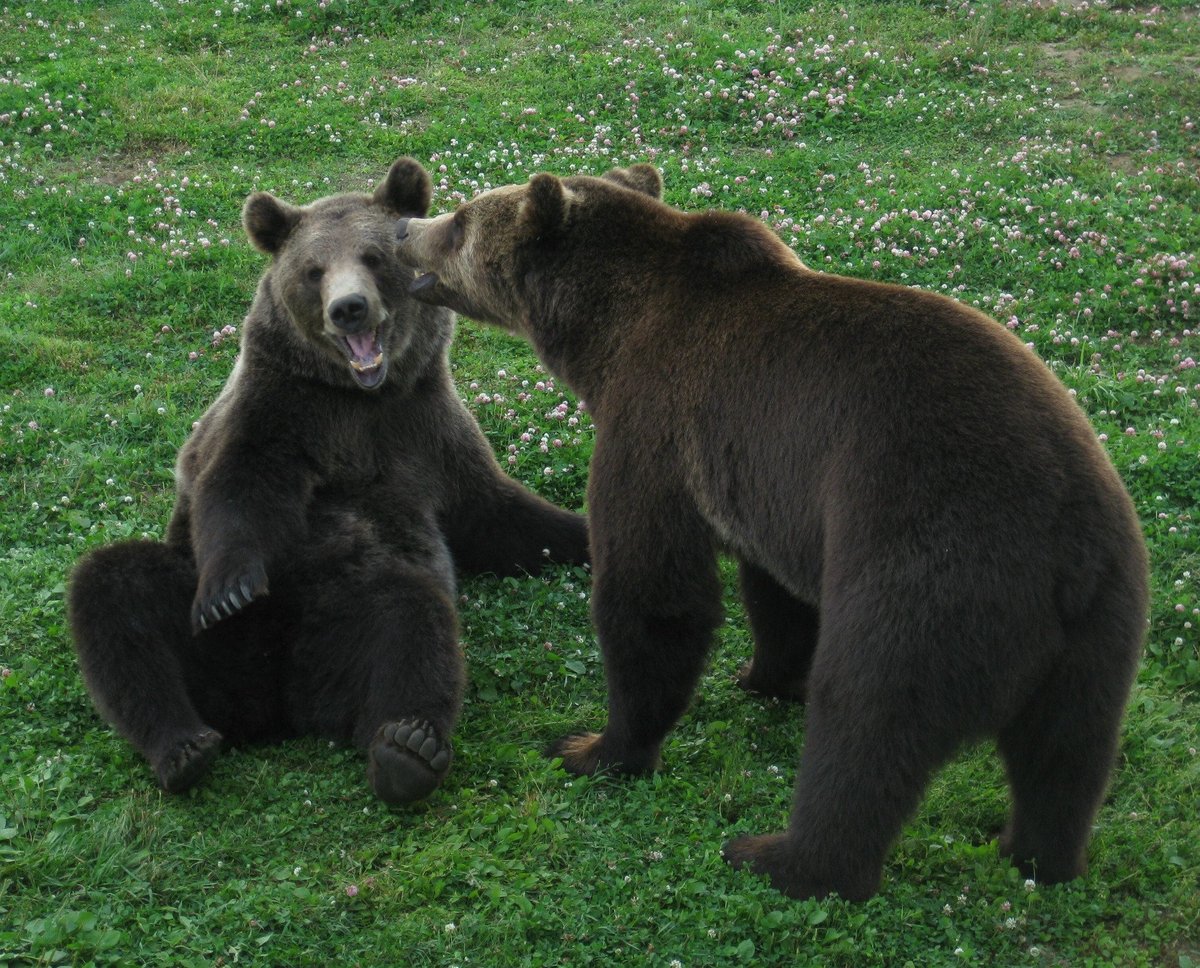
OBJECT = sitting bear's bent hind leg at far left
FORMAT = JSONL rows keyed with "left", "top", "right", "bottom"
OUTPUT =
{"left": 67, "top": 541, "right": 221, "bottom": 793}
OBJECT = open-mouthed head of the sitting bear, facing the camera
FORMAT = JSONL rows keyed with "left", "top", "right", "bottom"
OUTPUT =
{"left": 242, "top": 158, "right": 449, "bottom": 390}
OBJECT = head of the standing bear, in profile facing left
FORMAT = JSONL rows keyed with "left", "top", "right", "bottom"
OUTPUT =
{"left": 396, "top": 164, "right": 673, "bottom": 335}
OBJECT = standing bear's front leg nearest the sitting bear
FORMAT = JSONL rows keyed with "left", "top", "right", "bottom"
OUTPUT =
{"left": 548, "top": 472, "right": 721, "bottom": 775}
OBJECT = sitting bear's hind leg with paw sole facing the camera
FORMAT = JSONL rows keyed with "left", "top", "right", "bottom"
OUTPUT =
{"left": 288, "top": 509, "right": 466, "bottom": 805}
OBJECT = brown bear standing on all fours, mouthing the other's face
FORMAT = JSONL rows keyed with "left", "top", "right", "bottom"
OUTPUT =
{"left": 397, "top": 166, "right": 1147, "bottom": 898}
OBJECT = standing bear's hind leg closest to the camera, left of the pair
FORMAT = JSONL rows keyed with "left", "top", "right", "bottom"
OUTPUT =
{"left": 725, "top": 578, "right": 985, "bottom": 900}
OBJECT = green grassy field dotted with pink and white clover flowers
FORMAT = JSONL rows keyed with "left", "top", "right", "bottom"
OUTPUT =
{"left": 0, "top": 0, "right": 1200, "bottom": 968}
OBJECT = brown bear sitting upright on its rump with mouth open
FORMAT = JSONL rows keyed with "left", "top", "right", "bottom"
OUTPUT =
{"left": 68, "top": 158, "right": 587, "bottom": 804}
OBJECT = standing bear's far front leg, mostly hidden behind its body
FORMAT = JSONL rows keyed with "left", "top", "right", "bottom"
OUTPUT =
{"left": 738, "top": 560, "right": 820, "bottom": 702}
